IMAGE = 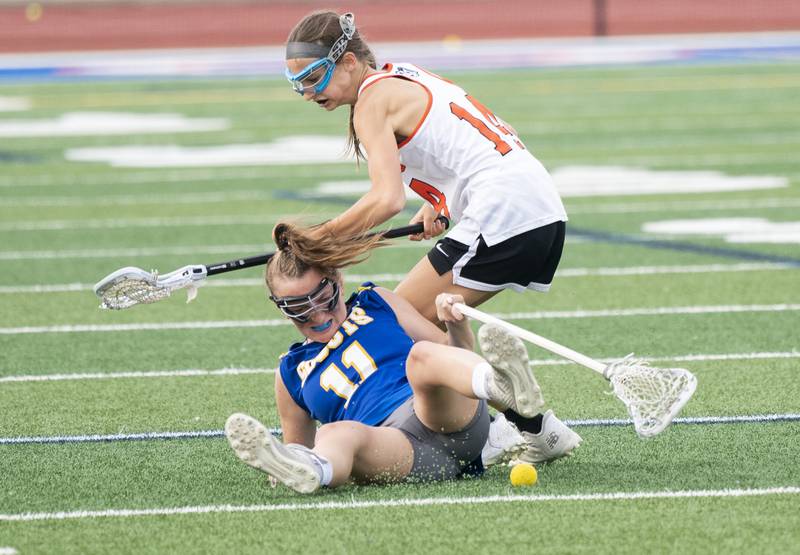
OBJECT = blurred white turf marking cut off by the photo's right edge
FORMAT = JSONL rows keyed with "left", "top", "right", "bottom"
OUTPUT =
{"left": 642, "top": 218, "right": 800, "bottom": 243}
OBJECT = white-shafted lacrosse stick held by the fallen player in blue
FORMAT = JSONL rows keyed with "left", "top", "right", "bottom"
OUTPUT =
{"left": 453, "top": 303, "right": 697, "bottom": 438}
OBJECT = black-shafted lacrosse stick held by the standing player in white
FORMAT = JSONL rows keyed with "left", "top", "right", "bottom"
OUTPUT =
{"left": 94, "top": 216, "right": 450, "bottom": 310}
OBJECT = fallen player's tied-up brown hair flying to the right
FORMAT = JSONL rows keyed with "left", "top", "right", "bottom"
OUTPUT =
{"left": 266, "top": 222, "right": 386, "bottom": 291}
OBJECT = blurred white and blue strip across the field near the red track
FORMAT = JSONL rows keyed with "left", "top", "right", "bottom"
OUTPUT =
{"left": 0, "top": 33, "right": 800, "bottom": 82}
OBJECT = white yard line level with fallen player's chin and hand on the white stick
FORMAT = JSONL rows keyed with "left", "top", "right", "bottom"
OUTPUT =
{"left": 0, "top": 304, "right": 800, "bottom": 335}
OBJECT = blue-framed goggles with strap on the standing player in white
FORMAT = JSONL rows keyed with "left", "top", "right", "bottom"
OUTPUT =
{"left": 284, "top": 13, "right": 356, "bottom": 95}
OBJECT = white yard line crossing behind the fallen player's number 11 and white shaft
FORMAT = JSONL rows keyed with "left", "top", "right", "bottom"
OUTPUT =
{"left": 0, "top": 351, "right": 800, "bottom": 383}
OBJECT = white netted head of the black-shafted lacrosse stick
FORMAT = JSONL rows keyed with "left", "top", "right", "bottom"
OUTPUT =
{"left": 94, "top": 265, "right": 207, "bottom": 310}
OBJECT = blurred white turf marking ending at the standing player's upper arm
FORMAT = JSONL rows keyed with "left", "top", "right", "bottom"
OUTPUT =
{"left": 65, "top": 135, "right": 353, "bottom": 168}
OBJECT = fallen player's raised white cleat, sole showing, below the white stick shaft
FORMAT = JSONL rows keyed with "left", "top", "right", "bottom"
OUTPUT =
{"left": 478, "top": 324, "right": 544, "bottom": 418}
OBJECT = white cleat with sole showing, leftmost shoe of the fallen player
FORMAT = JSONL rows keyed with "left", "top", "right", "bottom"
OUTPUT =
{"left": 225, "top": 413, "right": 322, "bottom": 493}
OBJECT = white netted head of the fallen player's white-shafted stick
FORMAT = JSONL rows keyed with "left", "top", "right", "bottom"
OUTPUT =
{"left": 603, "top": 355, "right": 697, "bottom": 438}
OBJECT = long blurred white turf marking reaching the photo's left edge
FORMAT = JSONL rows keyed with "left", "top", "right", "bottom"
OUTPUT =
{"left": 0, "top": 112, "right": 230, "bottom": 138}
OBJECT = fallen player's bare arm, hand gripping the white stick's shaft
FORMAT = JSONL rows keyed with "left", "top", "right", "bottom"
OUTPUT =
{"left": 375, "top": 287, "right": 475, "bottom": 351}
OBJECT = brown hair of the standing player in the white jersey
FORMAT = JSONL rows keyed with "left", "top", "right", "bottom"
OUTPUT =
{"left": 286, "top": 11, "right": 377, "bottom": 160}
